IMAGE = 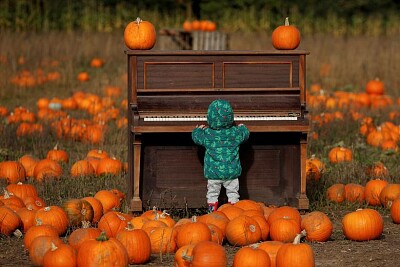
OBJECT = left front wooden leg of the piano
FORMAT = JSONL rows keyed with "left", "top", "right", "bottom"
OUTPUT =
{"left": 130, "top": 134, "right": 143, "bottom": 212}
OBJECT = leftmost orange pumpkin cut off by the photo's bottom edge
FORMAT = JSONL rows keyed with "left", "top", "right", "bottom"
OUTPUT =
{"left": 43, "top": 243, "right": 76, "bottom": 267}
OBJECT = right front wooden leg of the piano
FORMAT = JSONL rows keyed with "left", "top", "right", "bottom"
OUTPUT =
{"left": 298, "top": 133, "right": 309, "bottom": 210}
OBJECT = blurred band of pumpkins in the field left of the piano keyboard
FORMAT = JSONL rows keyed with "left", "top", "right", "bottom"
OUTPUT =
{"left": 0, "top": 86, "right": 128, "bottom": 144}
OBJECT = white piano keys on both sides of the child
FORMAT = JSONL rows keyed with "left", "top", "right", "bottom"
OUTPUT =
{"left": 143, "top": 116, "right": 297, "bottom": 122}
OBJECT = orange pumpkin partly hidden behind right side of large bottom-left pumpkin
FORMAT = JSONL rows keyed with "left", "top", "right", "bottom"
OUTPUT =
{"left": 116, "top": 222, "right": 151, "bottom": 264}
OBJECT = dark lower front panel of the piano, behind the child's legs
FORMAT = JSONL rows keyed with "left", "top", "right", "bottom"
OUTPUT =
{"left": 140, "top": 133, "right": 300, "bottom": 208}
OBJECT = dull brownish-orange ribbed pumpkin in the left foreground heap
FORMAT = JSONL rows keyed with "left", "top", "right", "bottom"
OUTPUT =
{"left": 62, "top": 199, "right": 94, "bottom": 226}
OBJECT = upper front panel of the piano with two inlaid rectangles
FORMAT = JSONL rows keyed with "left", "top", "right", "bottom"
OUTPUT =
{"left": 136, "top": 54, "right": 300, "bottom": 92}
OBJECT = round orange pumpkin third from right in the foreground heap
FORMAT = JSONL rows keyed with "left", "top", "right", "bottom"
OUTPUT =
{"left": 269, "top": 218, "right": 301, "bottom": 243}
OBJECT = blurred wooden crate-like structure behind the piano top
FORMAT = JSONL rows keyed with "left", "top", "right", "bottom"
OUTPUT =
{"left": 159, "top": 29, "right": 229, "bottom": 50}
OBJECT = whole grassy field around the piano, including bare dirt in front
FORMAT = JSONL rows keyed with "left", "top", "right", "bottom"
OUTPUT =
{"left": 0, "top": 32, "right": 400, "bottom": 266}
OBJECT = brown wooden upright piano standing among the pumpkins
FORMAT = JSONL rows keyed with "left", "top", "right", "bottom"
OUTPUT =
{"left": 126, "top": 50, "right": 309, "bottom": 212}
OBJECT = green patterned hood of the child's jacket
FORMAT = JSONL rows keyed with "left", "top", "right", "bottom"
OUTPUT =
{"left": 207, "top": 99, "right": 234, "bottom": 130}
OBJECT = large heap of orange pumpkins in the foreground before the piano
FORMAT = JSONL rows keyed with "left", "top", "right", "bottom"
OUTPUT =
{"left": 0, "top": 183, "right": 390, "bottom": 267}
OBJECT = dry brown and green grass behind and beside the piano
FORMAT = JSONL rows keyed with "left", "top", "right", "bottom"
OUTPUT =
{"left": 0, "top": 31, "right": 400, "bottom": 220}
